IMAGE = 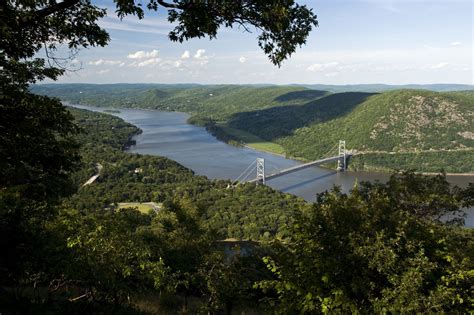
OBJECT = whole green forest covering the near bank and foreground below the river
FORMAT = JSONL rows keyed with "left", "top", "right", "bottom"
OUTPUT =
{"left": 0, "top": 108, "right": 474, "bottom": 313}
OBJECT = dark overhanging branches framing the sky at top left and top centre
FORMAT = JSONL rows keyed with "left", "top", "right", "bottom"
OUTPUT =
{"left": 0, "top": 0, "right": 318, "bottom": 88}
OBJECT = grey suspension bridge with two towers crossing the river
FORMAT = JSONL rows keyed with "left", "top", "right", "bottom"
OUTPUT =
{"left": 233, "top": 140, "right": 352, "bottom": 185}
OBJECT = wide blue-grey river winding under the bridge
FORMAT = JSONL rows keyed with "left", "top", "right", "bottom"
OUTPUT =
{"left": 74, "top": 105, "right": 474, "bottom": 227}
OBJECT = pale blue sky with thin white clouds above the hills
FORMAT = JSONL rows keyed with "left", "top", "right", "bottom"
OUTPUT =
{"left": 54, "top": 0, "right": 474, "bottom": 84}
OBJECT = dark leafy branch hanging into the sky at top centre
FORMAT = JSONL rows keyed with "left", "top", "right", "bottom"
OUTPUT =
{"left": 161, "top": 0, "right": 318, "bottom": 66}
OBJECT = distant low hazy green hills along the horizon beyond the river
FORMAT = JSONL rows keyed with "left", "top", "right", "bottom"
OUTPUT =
{"left": 32, "top": 84, "right": 329, "bottom": 119}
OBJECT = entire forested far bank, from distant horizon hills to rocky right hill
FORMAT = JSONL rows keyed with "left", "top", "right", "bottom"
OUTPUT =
{"left": 33, "top": 85, "right": 474, "bottom": 173}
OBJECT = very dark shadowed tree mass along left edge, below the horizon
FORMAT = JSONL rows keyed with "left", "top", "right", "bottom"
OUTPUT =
{"left": 0, "top": 88, "right": 79, "bottom": 284}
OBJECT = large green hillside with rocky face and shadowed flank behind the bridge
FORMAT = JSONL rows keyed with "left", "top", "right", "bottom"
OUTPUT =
{"left": 223, "top": 90, "right": 474, "bottom": 172}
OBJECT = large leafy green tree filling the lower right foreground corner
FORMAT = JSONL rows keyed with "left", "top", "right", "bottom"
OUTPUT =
{"left": 259, "top": 174, "right": 474, "bottom": 313}
